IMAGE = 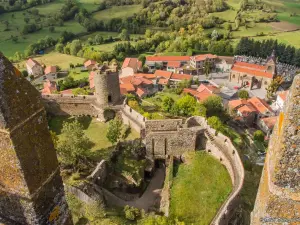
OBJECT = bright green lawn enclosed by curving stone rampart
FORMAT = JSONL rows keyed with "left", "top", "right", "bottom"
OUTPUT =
{"left": 170, "top": 152, "right": 232, "bottom": 225}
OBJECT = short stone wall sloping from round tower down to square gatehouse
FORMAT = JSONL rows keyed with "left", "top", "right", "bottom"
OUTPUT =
{"left": 121, "top": 103, "right": 146, "bottom": 133}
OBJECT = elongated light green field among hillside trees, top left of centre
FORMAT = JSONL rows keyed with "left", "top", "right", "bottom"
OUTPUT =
{"left": 93, "top": 5, "right": 142, "bottom": 21}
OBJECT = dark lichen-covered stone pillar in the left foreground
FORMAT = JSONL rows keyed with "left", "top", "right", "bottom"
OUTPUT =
{"left": 0, "top": 53, "right": 73, "bottom": 225}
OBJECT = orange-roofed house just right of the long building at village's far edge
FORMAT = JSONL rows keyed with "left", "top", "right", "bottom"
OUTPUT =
{"left": 190, "top": 54, "right": 218, "bottom": 74}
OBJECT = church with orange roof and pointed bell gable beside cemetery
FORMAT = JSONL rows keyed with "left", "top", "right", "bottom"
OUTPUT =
{"left": 229, "top": 58, "right": 276, "bottom": 90}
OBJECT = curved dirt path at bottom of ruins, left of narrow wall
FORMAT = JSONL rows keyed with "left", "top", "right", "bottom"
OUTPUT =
{"left": 102, "top": 168, "right": 165, "bottom": 212}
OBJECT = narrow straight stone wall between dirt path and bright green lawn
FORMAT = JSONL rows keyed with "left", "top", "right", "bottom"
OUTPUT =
{"left": 160, "top": 156, "right": 174, "bottom": 216}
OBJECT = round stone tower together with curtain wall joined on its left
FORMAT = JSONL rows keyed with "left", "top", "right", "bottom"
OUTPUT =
{"left": 42, "top": 66, "right": 122, "bottom": 121}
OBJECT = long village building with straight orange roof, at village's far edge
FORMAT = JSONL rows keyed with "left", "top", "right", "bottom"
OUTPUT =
{"left": 145, "top": 56, "right": 190, "bottom": 72}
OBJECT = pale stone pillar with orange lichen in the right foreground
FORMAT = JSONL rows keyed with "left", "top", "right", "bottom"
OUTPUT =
{"left": 251, "top": 75, "right": 300, "bottom": 225}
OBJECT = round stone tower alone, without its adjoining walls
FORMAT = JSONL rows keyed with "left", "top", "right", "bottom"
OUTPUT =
{"left": 94, "top": 66, "right": 121, "bottom": 106}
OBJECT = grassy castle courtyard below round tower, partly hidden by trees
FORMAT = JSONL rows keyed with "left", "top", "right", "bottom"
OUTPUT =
{"left": 49, "top": 116, "right": 139, "bottom": 158}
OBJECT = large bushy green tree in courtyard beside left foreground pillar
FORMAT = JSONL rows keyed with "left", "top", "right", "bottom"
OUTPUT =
{"left": 57, "top": 120, "right": 92, "bottom": 169}
